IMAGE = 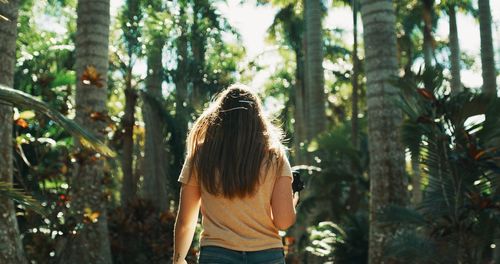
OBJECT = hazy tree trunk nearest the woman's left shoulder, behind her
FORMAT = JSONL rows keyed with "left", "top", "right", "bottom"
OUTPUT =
{"left": 142, "top": 37, "right": 173, "bottom": 212}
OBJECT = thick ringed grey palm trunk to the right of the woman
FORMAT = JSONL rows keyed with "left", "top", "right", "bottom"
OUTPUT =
{"left": 361, "top": 0, "right": 406, "bottom": 264}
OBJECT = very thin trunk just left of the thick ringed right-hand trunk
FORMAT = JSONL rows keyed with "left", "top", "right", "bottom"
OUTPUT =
{"left": 351, "top": 0, "right": 359, "bottom": 149}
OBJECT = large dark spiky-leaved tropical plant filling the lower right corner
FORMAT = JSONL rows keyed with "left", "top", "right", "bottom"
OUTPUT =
{"left": 380, "top": 67, "right": 500, "bottom": 263}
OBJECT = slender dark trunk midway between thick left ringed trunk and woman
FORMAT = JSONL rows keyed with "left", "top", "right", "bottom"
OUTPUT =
{"left": 121, "top": 68, "right": 137, "bottom": 205}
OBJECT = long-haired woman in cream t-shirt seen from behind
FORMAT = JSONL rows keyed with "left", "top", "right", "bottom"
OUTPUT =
{"left": 173, "top": 85, "right": 298, "bottom": 264}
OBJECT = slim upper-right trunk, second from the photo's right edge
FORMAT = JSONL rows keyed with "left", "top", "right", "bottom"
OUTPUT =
{"left": 448, "top": 4, "right": 463, "bottom": 93}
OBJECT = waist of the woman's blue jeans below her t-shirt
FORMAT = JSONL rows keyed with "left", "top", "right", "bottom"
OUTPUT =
{"left": 199, "top": 246, "right": 285, "bottom": 264}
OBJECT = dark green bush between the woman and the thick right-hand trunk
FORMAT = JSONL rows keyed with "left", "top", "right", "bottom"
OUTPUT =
{"left": 300, "top": 123, "right": 368, "bottom": 222}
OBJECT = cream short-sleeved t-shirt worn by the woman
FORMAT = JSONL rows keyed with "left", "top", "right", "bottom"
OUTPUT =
{"left": 178, "top": 158, "right": 293, "bottom": 251}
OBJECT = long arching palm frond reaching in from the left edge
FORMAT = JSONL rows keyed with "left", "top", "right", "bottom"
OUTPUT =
{"left": 0, "top": 85, "right": 116, "bottom": 157}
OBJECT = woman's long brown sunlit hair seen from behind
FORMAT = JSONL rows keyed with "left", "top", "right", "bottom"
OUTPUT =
{"left": 187, "top": 84, "right": 284, "bottom": 198}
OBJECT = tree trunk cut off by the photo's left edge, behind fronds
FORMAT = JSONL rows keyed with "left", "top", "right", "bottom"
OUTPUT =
{"left": 0, "top": 0, "right": 27, "bottom": 264}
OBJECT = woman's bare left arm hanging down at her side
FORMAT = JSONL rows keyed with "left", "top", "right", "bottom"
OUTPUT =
{"left": 173, "top": 184, "right": 201, "bottom": 264}
